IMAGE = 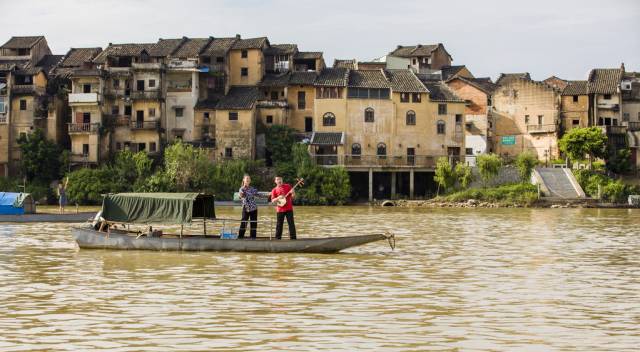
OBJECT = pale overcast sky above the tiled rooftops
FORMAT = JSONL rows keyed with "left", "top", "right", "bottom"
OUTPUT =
{"left": 0, "top": 0, "right": 640, "bottom": 80}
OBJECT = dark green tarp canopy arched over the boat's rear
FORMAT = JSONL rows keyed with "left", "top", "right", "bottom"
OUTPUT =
{"left": 102, "top": 193, "right": 216, "bottom": 224}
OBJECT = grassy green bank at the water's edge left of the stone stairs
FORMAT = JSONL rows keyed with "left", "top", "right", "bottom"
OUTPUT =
{"left": 433, "top": 183, "right": 538, "bottom": 206}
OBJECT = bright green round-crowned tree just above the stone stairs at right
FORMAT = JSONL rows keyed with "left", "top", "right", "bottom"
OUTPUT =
{"left": 558, "top": 126, "right": 607, "bottom": 167}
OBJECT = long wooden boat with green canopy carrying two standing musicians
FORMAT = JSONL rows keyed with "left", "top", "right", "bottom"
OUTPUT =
{"left": 71, "top": 193, "right": 395, "bottom": 253}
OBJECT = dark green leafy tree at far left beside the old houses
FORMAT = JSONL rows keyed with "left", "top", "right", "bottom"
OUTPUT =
{"left": 18, "top": 128, "right": 64, "bottom": 184}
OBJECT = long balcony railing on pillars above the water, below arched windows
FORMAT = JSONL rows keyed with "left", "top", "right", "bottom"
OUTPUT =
{"left": 311, "top": 154, "right": 461, "bottom": 169}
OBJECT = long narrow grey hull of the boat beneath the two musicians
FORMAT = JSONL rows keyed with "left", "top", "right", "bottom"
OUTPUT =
{"left": 71, "top": 228, "right": 387, "bottom": 253}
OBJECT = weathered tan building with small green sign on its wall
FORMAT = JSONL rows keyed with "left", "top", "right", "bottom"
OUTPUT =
{"left": 492, "top": 74, "right": 560, "bottom": 161}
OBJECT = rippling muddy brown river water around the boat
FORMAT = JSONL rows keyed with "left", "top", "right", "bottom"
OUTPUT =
{"left": 0, "top": 207, "right": 640, "bottom": 351}
